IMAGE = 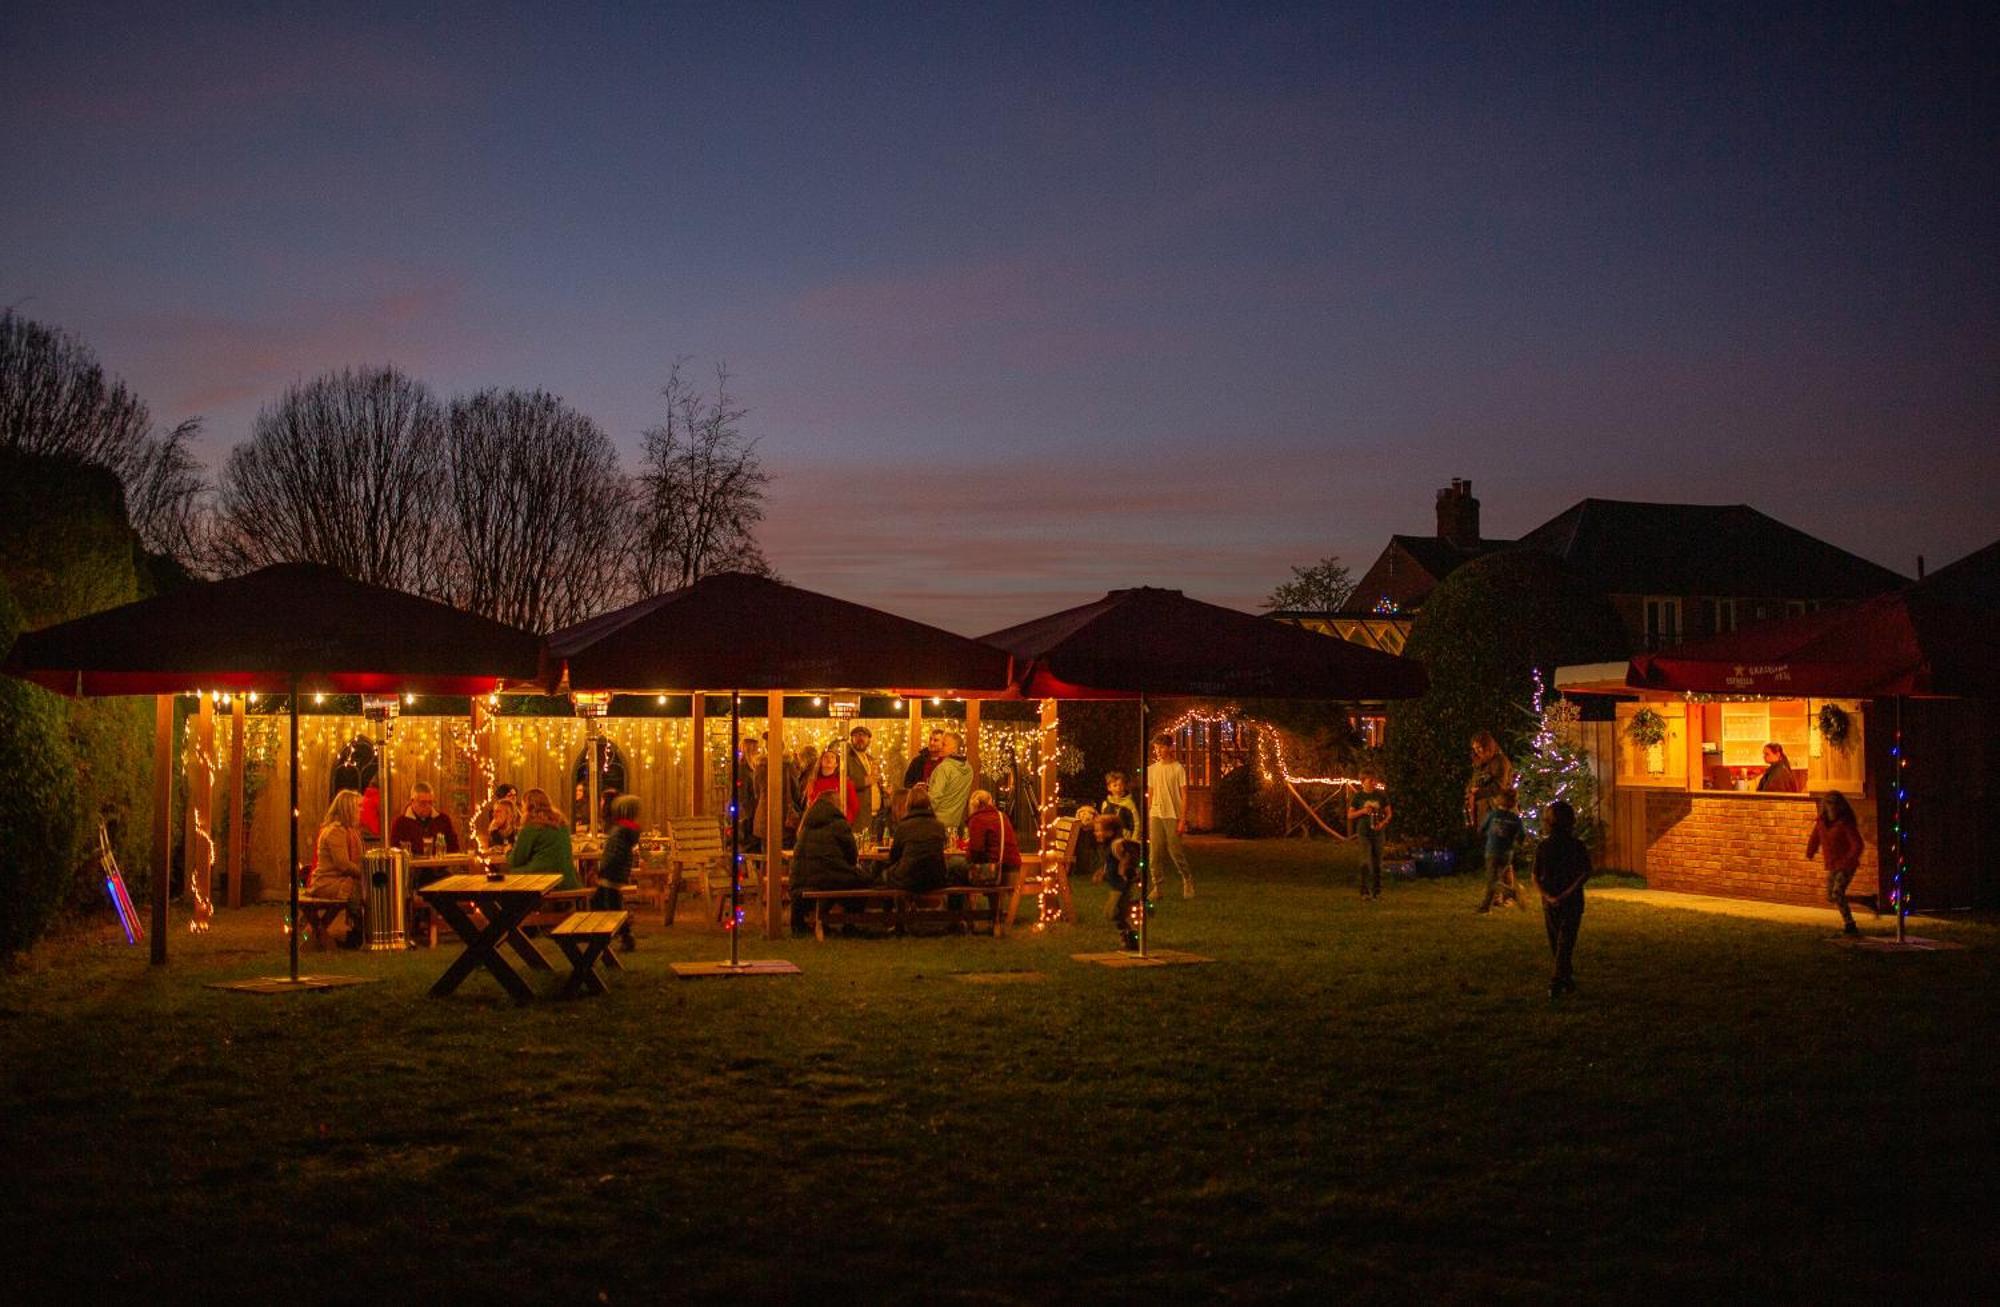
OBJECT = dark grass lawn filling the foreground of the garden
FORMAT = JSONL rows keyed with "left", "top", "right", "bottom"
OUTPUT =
{"left": 0, "top": 841, "right": 2000, "bottom": 1303}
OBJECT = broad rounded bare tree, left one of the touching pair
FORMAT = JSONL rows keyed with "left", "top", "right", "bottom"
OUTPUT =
{"left": 214, "top": 368, "right": 448, "bottom": 596}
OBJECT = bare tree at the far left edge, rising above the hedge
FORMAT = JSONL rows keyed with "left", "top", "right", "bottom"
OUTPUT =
{"left": 0, "top": 310, "right": 206, "bottom": 560}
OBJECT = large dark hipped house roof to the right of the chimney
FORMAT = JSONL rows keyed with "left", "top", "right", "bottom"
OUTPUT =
{"left": 1512, "top": 500, "right": 1908, "bottom": 600}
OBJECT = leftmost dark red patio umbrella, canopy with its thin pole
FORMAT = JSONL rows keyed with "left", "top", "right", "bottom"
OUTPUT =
{"left": 0, "top": 564, "right": 538, "bottom": 981}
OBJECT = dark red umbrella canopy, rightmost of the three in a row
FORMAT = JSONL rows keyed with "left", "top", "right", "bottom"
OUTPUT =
{"left": 982, "top": 588, "right": 1430, "bottom": 699}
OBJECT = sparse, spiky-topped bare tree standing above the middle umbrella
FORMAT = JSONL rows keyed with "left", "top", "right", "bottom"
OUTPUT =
{"left": 626, "top": 360, "right": 770, "bottom": 594}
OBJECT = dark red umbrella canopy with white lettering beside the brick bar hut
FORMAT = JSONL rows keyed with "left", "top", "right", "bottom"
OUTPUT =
{"left": 1626, "top": 587, "right": 2000, "bottom": 699}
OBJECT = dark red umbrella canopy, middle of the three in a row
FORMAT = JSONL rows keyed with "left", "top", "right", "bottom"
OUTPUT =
{"left": 544, "top": 572, "right": 1012, "bottom": 697}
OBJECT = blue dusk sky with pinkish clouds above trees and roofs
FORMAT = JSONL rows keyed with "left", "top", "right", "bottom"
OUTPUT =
{"left": 0, "top": 2, "right": 2000, "bottom": 632}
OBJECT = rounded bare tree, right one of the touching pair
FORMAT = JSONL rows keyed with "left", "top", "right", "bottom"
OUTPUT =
{"left": 444, "top": 390, "right": 630, "bottom": 632}
